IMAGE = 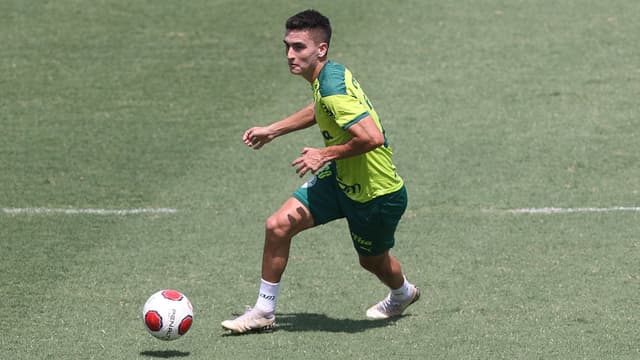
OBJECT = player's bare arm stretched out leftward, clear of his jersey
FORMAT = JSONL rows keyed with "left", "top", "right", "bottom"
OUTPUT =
{"left": 242, "top": 103, "right": 316, "bottom": 150}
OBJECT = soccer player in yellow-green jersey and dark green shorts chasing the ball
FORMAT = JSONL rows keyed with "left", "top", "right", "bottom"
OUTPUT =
{"left": 222, "top": 10, "right": 420, "bottom": 333}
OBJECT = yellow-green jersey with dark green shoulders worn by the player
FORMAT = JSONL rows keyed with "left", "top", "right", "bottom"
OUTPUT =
{"left": 311, "top": 61, "right": 403, "bottom": 202}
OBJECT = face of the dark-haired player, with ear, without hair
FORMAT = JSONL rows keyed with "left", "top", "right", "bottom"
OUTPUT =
{"left": 284, "top": 30, "right": 328, "bottom": 81}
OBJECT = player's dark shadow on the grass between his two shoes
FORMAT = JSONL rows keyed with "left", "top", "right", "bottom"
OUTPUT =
{"left": 276, "top": 313, "right": 406, "bottom": 334}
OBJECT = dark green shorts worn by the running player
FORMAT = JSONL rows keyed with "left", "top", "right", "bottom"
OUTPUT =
{"left": 293, "top": 166, "right": 407, "bottom": 256}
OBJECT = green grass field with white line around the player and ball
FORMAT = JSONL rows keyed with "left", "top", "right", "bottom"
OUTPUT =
{"left": 0, "top": 0, "right": 640, "bottom": 360}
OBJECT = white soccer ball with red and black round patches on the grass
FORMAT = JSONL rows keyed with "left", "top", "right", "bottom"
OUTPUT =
{"left": 142, "top": 290, "right": 193, "bottom": 340}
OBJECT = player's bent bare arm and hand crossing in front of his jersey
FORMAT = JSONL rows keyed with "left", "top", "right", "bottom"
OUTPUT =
{"left": 291, "top": 115, "right": 384, "bottom": 177}
